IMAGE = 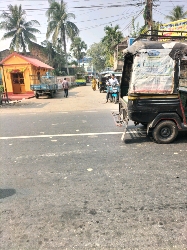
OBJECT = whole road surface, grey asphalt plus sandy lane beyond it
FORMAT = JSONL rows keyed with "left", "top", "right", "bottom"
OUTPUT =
{"left": 0, "top": 86, "right": 187, "bottom": 250}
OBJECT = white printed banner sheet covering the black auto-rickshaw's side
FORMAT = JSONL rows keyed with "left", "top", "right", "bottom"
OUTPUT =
{"left": 130, "top": 49, "right": 174, "bottom": 94}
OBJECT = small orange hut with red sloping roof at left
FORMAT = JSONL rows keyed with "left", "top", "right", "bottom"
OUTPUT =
{"left": 0, "top": 52, "right": 53, "bottom": 95}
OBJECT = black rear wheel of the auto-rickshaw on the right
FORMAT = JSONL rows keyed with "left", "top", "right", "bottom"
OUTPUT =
{"left": 153, "top": 120, "right": 178, "bottom": 144}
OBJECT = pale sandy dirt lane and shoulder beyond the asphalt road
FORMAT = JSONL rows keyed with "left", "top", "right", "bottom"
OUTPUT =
{"left": 0, "top": 85, "right": 118, "bottom": 113}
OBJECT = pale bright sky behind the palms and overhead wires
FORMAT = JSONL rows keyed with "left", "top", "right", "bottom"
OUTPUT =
{"left": 0, "top": 0, "right": 187, "bottom": 51}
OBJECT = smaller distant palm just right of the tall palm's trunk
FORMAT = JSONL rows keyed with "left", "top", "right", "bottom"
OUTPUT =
{"left": 70, "top": 37, "right": 87, "bottom": 66}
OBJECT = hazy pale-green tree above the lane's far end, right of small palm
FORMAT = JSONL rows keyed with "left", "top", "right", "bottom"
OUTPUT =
{"left": 87, "top": 42, "right": 106, "bottom": 72}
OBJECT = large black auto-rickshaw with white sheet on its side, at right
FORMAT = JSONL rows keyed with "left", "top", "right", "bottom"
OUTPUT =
{"left": 119, "top": 38, "right": 187, "bottom": 143}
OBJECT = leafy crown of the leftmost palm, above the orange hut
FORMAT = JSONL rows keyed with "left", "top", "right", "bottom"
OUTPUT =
{"left": 0, "top": 4, "right": 40, "bottom": 53}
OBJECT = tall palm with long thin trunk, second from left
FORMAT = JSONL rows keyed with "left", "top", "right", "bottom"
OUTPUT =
{"left": 46, "top": 0, "right": 79, "bottom": 74}
